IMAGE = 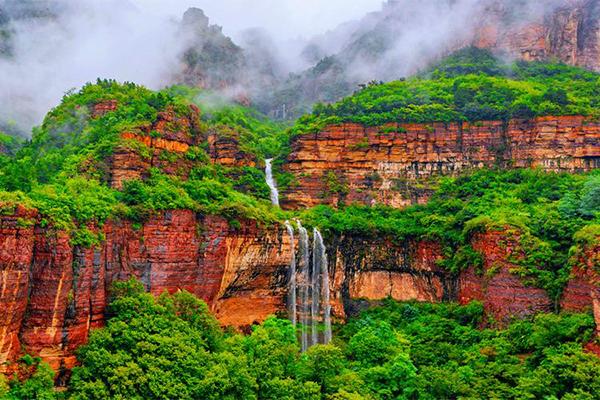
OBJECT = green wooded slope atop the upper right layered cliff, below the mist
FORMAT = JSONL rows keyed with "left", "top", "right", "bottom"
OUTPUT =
{"left": 294, "top": 48, "right": 600, "bottom": 133}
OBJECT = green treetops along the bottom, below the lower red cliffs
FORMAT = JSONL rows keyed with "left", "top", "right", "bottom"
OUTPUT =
{"left": 11, "top": 281, "right": 600, "bottom": 400}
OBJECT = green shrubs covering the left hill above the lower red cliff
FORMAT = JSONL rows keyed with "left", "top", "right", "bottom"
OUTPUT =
{"left": 0, "top": 80, "right": 289, "bottom": 246}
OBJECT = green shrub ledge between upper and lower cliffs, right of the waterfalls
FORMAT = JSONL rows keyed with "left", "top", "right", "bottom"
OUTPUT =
{"left": 301, "top": 169, "right": 600, "bottom": 299}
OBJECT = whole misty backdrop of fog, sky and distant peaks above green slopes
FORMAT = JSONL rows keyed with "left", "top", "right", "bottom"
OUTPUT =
{"left": 0, "top": 0, "right": 592, "bottom": 132}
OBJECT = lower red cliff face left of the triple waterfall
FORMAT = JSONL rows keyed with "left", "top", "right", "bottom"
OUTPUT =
{"left": 0, "top": 210, "right": 290, "bottom": 372}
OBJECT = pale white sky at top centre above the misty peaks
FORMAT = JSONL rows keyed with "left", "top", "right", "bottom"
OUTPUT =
{"left": 132, "top": 0, "right": 383, "bottom": 40}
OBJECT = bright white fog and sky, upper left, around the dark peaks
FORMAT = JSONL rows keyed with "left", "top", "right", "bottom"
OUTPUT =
{"left": 0, "top": 0, "right": 382, "bottom": 130}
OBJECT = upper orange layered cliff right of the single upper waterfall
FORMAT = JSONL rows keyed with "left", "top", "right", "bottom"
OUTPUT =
{"left": 282, "top": 117, "right": 600, "bottom": 208}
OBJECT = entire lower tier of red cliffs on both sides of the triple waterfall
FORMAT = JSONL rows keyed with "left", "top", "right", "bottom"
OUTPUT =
{"left": 0, "top": 208, "right": 600, "bottom": 373}
